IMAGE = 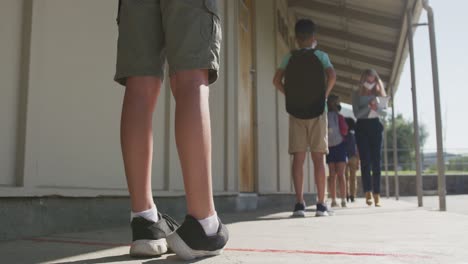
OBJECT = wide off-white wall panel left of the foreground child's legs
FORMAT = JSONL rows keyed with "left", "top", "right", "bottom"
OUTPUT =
{"left": 25, "top": 0, "right": 125, "bottom": 188}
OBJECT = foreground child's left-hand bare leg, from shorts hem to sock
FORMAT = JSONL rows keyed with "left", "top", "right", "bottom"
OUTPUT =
{"left": 120, "top": 77, "right": 161, "bottom": 212}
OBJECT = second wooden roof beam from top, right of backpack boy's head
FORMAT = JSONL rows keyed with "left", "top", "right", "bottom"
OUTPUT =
{"left": 317, "top": 26, "right": 396, "bottom": 52}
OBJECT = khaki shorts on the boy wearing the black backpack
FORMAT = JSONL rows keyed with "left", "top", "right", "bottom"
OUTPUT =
{"left": 289, "top": 112, "right": 328, "bottom": 154}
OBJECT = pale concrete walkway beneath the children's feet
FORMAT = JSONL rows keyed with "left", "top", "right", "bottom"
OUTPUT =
{"left": 0, "top": 196, "right": 468, "bottom": 264}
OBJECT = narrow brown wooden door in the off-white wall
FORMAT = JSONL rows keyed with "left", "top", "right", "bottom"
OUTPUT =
{"left": 238, "top": 0, "right": 256, "bottom": 192}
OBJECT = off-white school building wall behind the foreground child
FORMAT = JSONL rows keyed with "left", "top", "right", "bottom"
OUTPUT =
{"left": 0, "top": 0, "right": 315, "bottom": 197}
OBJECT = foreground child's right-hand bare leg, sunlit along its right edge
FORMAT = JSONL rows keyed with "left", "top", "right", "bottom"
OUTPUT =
{"left": 171, "top": 70, "right": 215, "bottom": 219}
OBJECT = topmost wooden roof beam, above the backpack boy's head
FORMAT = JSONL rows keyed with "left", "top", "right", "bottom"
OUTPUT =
{"left": 288, "top": 0, "right": 402, "bottom": 29}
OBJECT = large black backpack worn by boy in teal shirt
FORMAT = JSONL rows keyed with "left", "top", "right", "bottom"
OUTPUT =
{"left": 284, "top": 49, "right": 326, "bottom": 119}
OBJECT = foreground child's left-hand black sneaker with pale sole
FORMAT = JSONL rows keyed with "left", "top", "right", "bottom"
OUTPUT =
{"left": 130, "top": 213, "right": 179, "bottom": 257}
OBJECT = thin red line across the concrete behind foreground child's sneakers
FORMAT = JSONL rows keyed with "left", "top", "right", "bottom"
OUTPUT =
{"left": 23, "top": 238, "right": 431, "bottom": 259}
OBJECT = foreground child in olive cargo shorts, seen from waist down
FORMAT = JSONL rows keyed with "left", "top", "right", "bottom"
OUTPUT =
{"left": 115, "top": 0, "right": 228, "bottom": 259}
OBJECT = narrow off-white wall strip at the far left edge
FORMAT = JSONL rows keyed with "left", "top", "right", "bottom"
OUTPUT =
{"left": 0, "top": 0, "right": 23, "bottom": 186}
